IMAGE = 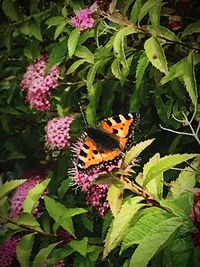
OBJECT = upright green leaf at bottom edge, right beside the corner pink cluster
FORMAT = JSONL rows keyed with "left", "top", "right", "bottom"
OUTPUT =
{"left": 16, "top": 234, "right": 34, "bottom": 267}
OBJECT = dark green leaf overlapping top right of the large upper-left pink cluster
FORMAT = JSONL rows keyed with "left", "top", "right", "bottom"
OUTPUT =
{"left": 45, "top": 39, "right": 67, "bottom": 73}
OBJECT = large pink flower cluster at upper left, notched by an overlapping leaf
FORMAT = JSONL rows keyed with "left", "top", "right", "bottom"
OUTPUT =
{"left": 20, "top": 56, "right": 60, "bottom": 112}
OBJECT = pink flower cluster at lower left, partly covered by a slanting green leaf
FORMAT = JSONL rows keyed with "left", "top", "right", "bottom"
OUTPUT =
{"left": 9, "top": 171, "right": 47, "bottom": 219}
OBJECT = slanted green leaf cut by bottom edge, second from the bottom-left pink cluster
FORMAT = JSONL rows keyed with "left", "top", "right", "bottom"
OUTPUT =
{"left": 32, "top": 243, "right": 58, "bottom": 267}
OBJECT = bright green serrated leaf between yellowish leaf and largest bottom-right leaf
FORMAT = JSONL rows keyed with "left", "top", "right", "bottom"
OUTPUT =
{"left": 120, "top": 207, "right": 171, "bottom": 253}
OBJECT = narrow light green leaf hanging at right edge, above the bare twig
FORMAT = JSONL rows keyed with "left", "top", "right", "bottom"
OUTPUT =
{"left": 183, "top": 54, "right": 197, "bottom": 105}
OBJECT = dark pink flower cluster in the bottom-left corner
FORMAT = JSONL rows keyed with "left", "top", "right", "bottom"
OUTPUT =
{"left": 0, "top": 236, "right": 20, "bottom": 267}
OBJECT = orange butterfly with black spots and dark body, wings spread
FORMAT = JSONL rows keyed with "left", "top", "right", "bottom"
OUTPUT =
{"left": 77, "top": 113, "right": 139, "bottom": 173}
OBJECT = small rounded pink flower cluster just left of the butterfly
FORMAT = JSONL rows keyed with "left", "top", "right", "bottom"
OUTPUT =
{"left": 46, "top": 116, "right": 73, "bottom": 149}
